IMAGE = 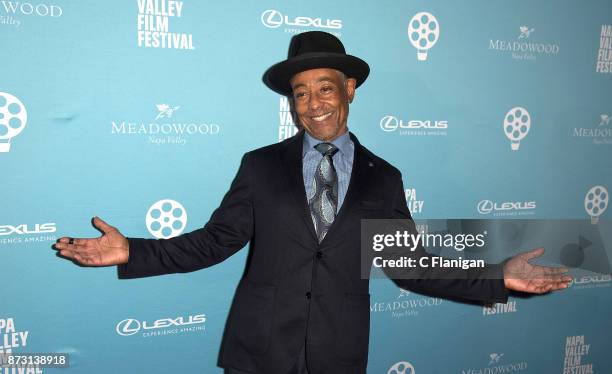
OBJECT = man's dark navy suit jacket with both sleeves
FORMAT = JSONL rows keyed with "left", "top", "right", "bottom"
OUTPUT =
{"left": 118, "top": 132, "right": 507, "bottom": 374}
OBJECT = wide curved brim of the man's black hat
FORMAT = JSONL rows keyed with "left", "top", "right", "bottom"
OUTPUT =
{"left": 263, "top": 52, "right": 370, "bottom": 96}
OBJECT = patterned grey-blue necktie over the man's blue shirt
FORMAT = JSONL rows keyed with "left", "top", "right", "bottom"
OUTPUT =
{"left": 308, "top": 143, "right": 338, "bottom": 243}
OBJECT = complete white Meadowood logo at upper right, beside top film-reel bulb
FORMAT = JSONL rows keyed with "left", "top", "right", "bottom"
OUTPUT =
{"left": 489, "top": 26, "right": 559, "bottom": 60}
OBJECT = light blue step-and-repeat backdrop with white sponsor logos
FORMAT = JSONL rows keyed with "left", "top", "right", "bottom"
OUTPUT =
{"left": 0, "top": 0, "right": 612, "bottom": 374}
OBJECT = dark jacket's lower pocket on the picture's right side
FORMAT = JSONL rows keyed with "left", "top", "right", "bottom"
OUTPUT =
{"left": 336, "top": 294, "right": 370, "bottom": 365}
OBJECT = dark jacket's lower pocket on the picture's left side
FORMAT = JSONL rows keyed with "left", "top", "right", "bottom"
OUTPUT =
{"left": 229, "top": 281, "right": 276, "bottom": 355}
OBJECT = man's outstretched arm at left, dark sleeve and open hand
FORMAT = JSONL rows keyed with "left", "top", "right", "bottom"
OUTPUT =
{"left": 55, "top": 154, "right": 253, "bottom": 278}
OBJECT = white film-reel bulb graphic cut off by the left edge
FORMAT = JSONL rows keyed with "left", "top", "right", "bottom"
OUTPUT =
{"left": 0, "top": 92, "right": 28, "bottom": 152}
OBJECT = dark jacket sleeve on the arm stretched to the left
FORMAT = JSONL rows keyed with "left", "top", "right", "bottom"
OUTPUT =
{"left": 117, "top": 153, "right": 254, "bottom": 279}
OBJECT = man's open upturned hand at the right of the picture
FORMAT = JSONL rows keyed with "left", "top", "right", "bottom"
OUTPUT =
{"left": 504, "top": 248, "right": 572, "bottom": 293}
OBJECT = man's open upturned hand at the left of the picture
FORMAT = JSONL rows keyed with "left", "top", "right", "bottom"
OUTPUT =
{"left": 54, "top": 217, "right": 129, "bottom": 266}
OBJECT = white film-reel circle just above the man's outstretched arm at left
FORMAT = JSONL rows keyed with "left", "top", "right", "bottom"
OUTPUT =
{"left": 146, "top": 199, "right": 187, "bottom": 239}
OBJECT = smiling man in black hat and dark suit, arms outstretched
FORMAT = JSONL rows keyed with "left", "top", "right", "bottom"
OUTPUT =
{"left": 56, "top": 32, "right": 571, "bottom": 374}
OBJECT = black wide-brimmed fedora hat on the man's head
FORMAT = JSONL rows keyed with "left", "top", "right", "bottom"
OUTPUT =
{"left": 263, "top": 31, "right": 370, "bottom": 96}
